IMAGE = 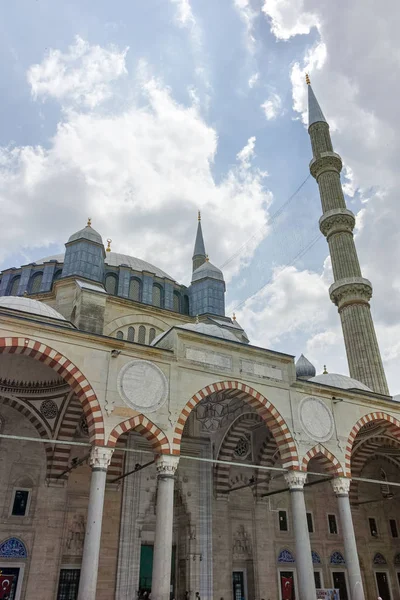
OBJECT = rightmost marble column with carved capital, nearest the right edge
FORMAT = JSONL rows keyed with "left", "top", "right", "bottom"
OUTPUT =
{"left": 332, "top": 477, "right": 364, "bottom": 600}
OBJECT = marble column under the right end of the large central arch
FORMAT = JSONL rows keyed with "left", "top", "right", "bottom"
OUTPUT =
{"left": 285, "top": 471, "right": 317, "bottom": 600}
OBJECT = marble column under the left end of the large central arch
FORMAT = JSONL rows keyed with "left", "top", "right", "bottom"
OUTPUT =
{"left": 151, "top": 454, "right": 179, "bottom": 600}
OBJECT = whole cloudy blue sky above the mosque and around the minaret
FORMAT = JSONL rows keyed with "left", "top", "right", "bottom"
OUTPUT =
{"left": 0, "top": 0, "right": 400, "bottom": 393}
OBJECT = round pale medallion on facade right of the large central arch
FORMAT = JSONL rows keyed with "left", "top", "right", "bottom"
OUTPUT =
{"left": 299, "top": 397, "right": 333, "bottom": 442}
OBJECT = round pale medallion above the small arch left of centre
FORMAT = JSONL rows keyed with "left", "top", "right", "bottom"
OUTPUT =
{"left": 117, "top": 360, "right": 168, "bottom": 412}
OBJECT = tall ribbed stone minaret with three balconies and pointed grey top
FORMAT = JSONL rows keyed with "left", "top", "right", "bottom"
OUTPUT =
{"left": 306, "top": 75, "right": 389, "bottom": 395}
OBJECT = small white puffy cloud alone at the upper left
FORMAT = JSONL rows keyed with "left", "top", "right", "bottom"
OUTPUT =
{"left": 27, "top": 36, "right": 128, "bottom": 108}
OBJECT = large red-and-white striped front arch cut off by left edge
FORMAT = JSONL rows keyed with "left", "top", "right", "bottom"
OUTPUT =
{"left": 0, "top": 337, "right": 104, "bottom": 445}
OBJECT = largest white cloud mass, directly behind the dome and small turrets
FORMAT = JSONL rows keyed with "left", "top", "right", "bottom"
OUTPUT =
{"left": 0, "top": 40, "right": 272, "bottom": 283}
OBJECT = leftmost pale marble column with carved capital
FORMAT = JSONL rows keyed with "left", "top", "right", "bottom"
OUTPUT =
{"left": 78, "top": 446, "right": 114, "bottom": 600}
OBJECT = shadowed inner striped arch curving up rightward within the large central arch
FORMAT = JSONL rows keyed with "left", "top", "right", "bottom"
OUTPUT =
{"left": 214, "top": 412, "right": 263, "bottom": 497}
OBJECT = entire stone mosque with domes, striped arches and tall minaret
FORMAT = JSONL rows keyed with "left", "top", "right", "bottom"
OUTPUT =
{"left": 0, "top": 80, "right": 400, "bottom": 600}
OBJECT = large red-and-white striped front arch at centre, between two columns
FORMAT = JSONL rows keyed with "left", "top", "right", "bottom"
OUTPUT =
{"left": 172, "top": 381, "right": 299, "bottom": 470}
